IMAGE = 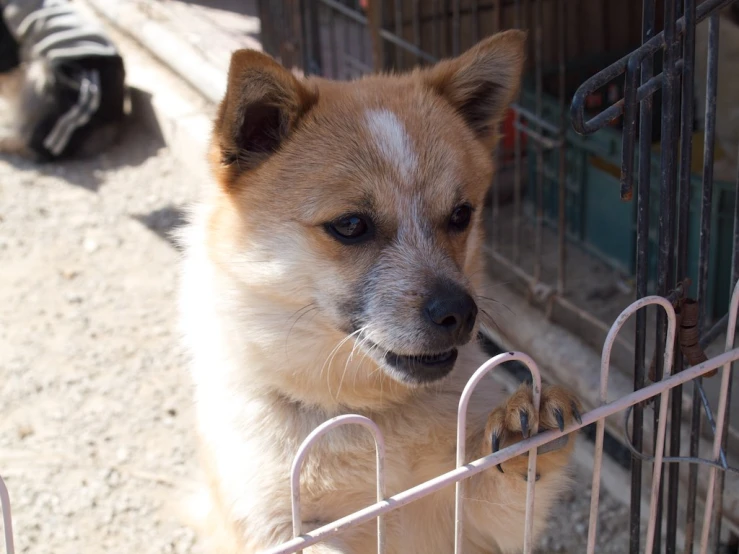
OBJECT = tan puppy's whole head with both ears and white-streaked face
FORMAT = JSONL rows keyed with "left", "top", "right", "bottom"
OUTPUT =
{"left": 211, "top": 31, "right": 525, "bottom": 384}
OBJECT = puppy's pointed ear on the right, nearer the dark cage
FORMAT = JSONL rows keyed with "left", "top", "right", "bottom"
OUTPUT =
{"left": 421, "top": 30, "right": 526, "bottom": 144}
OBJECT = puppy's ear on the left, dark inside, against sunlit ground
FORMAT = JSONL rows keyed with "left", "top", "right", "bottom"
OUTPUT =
{"left": 213, "top": 50, "right": 317, "bottom": 180}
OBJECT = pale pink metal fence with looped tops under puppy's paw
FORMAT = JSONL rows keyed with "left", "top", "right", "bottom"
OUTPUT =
{"left": 0, "top": 283, "right": 739, "bottom": 554}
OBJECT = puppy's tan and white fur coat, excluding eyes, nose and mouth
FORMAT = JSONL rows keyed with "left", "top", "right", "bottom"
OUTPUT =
{"left": 181, "top": 31, "right": 576, "bottom": 554}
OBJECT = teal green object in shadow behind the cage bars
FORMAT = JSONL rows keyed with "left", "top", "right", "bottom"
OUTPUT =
{"left": 521, "top": 86, "right": 736, "bottom": 320}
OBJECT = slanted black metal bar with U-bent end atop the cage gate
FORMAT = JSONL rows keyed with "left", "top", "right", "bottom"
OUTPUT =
{"left": 571, "top": 0, "right": 734, "bottom": 135}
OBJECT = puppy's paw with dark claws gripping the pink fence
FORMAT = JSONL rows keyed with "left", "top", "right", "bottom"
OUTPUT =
{"left": 485, "top": 384, "right": 582, "bottom": 480}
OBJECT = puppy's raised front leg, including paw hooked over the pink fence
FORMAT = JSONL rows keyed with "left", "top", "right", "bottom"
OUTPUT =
{"left": 465, "top": 385, "right": 582, "bottom": 552}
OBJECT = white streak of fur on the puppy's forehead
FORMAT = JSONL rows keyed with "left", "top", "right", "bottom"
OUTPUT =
{"left": 366, "top": 109, "right": 418, "bottom": 179}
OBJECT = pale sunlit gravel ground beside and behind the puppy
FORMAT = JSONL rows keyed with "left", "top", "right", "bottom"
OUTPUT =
{"left": 0, "top": 63, "right": 628, "bottom": 554}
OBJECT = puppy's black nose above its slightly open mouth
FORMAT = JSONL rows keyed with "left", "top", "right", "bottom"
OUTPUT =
{"left": 423, "top": 283, "right": 477, "bottom": 342}
